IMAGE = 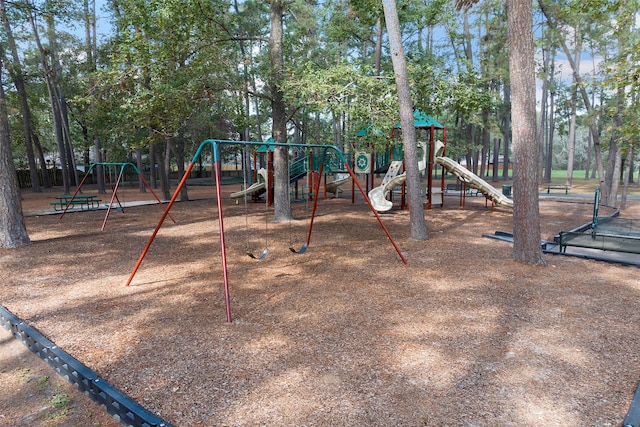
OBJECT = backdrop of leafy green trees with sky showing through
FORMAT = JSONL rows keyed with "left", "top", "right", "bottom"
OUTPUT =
{"left": 2, "top": 0, "right": 640, "bottom": 254}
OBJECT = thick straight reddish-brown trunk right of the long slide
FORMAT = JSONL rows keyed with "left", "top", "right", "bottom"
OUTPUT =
{"left": 507, "top": 0, "right": 545, "bottom": 265}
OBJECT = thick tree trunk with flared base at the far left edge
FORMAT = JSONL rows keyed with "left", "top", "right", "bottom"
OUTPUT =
{"left": 0, "top": 49, "right": 31, "bottom": 248}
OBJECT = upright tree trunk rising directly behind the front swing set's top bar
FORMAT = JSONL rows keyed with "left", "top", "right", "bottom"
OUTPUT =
{"left": 269, "top": 0, "right": 292, "bottom": 222}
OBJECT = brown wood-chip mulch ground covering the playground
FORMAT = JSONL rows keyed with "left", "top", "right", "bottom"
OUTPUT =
{"left": 0, "top": 179, "right": 640, "bottom": 426}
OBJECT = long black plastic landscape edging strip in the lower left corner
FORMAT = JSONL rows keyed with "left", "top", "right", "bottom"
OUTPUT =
{"left": 0, "top": 305, "right": 171, "bottom": 427}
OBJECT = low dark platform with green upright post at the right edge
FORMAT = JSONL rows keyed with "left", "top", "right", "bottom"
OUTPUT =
{"left": 555, "top": 188, "right": 640, "bottom": 262}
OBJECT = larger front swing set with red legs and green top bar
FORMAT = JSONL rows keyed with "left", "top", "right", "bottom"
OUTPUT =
{"left": 126, "top": 139, "right": 407, "bottom": 323}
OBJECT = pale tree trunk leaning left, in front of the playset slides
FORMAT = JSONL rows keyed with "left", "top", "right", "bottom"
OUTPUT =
{"left": 382, "top": 0, "right": 428, "bottom": 240}
